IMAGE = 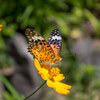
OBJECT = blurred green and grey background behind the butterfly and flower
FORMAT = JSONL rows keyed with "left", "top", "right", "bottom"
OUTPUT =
{"left": 0, "top": 0, "right": 100, "bottom": 100}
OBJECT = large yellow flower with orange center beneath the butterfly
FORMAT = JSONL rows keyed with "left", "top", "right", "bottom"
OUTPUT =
{"left": 34, "top": 59, "right": 71, "bottom": 94}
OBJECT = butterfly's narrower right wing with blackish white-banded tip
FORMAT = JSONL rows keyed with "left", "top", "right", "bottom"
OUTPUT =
{"left": 48, "top": 29, "right": 62, "bottom": 56}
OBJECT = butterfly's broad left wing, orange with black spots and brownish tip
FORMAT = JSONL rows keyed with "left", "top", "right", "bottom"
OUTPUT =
{"left": 25, "top": 28, "right": 55, "bottom": 63}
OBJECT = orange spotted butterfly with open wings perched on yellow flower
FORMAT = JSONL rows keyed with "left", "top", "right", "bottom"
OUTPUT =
{"left": 25, "top": 28, "right": 62, "bottom": 65}
